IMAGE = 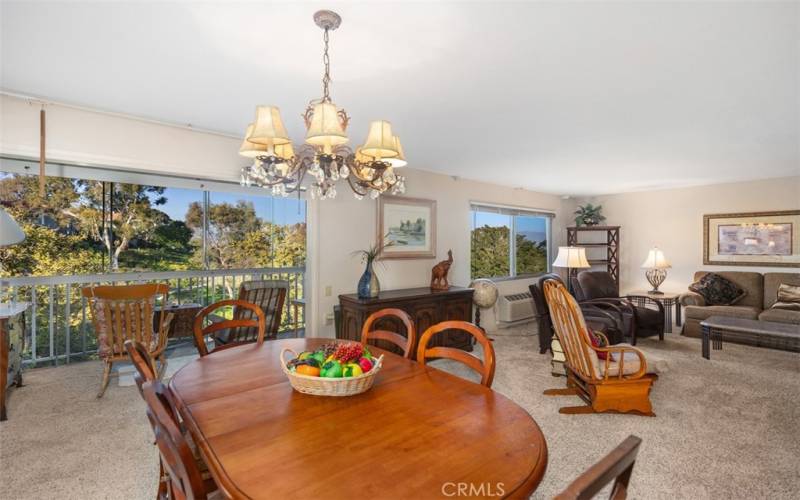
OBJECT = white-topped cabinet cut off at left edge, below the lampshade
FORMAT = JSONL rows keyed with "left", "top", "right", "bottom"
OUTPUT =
{"left": 0, "top": 302, "right": 28, "bottom": 421}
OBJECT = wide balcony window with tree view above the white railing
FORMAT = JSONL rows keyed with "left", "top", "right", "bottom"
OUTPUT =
{"left": 0, "top": 158, "right": 306, "bottom": 276}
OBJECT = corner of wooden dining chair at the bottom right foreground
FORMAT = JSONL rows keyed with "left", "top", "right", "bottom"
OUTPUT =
{"left": 554, "top": 435, "right": 642, "bottom": 500}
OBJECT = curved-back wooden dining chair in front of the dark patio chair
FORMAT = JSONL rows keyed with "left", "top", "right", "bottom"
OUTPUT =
{"left": 194, "top": 299, "right": 267, "bottom": 356}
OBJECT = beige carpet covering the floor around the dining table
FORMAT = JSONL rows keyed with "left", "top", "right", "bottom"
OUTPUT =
{"left": 0, "top": 327, "right": 800, "bottom": 499}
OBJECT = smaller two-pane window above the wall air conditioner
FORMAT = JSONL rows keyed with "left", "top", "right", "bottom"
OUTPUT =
{"left": 470, "top": 203, "right": 553, "bottom": 279}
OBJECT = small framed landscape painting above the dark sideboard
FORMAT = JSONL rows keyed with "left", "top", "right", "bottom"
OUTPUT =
{"left": 377, "top": 196, "right": 436, "bottom": 259}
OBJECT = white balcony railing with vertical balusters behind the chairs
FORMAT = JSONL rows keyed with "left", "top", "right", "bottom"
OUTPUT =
{"left": 0, "top": 267, "right": 305, "bottom": 365}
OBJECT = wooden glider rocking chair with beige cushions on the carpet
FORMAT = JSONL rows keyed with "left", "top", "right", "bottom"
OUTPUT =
{"left": 544, "top": 280, "right": 657, "bottom": 416}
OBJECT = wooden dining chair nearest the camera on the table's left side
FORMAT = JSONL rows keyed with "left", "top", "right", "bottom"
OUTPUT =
{"left": 142, "top": 380, "right": 219, "bottom": 500}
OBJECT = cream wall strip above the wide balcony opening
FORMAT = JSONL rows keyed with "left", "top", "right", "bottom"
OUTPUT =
{"left": 0, "top": 95, "right": 243, "bottom": 181}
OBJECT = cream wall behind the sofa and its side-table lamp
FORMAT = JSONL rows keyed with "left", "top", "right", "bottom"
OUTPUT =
{"left": 580, "top": 176, "right": 800, "bottom": 292}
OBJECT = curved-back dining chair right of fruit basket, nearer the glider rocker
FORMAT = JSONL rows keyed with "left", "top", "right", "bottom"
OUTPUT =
{"left": 417, "top": 321, "right": 495, "bottom": 387}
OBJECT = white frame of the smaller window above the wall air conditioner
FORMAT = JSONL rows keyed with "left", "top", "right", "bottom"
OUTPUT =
{"left": 469, "top": 201, "right": 555, "bottom": 281}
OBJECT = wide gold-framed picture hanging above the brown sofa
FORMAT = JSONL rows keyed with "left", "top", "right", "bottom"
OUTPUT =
{"left": 703, "top": 210, "right": 800, "bottom": 267}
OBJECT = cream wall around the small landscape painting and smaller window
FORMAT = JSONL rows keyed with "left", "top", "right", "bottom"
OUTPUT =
{"left": 312, "top": 169, "right": 569, "bottom": 336}
